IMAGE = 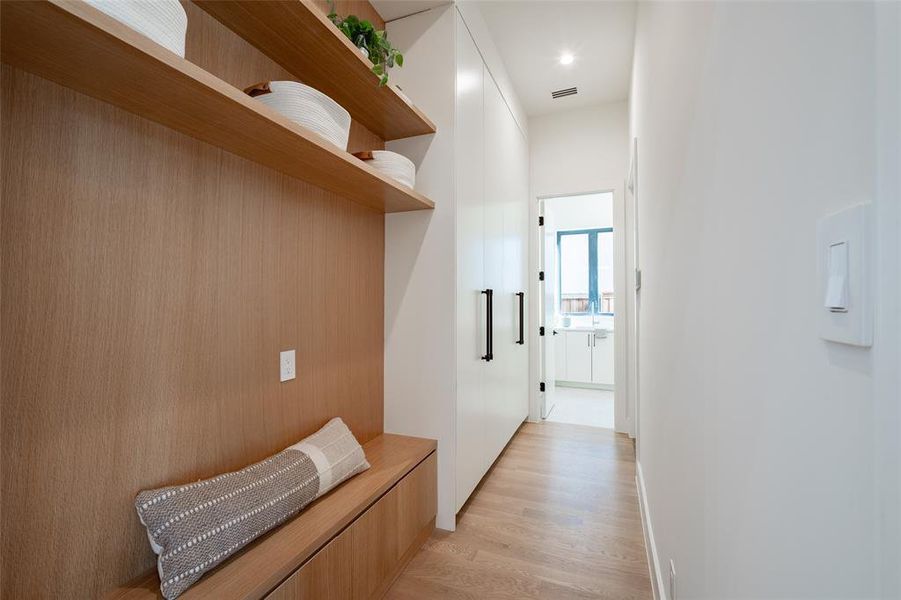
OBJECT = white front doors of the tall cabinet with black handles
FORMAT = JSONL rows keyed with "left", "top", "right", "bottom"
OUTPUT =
{"left": 455, "top": 16, "right": 528, "bottom": 510}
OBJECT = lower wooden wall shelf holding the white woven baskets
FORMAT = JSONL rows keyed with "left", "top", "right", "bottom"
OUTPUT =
{"left": 0, "top": 0, "right": 434, "bottom": 212}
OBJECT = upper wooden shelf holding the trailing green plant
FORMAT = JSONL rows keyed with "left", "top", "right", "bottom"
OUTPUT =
{"left": 197, "top": 0, "right": 435, "bottom": 140}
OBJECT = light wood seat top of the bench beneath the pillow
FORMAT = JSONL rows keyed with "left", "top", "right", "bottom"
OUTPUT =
{"left": 105, "top": 433, "right": 437, "bottom": 600}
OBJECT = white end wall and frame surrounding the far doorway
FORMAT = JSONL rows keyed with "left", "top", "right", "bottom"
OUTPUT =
{"left": 529, "top": 102, "right": 634, "bottom": 433}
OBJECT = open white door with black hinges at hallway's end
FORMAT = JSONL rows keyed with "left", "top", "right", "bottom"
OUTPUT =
{"left": 539, "top": 200, "right": 557, "bottom": 419}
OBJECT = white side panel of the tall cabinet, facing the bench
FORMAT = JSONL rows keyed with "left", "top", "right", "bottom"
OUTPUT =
{"left": 385, "top": 5, "right": 457, "bottom": 531}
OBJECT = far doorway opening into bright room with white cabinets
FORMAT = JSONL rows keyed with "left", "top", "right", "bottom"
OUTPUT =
{"left": 539, "top": 190, "right": 618, "bottom": 429}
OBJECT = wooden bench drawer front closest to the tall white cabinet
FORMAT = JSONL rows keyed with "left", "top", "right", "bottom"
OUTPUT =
{"left": 349, "top": 453, "right": 438, "bottom": 600}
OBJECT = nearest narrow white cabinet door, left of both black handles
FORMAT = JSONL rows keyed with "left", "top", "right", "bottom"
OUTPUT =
{"left": 455, "top": 23, "right": 488, "bottom": 510}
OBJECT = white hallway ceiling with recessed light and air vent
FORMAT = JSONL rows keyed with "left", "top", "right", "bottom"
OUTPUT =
{"left": 474, "top": 0, "right": 637, "bottom": 116}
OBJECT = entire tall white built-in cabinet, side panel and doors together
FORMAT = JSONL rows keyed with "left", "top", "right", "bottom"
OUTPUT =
{"left": 385, "top": 5, "right": 531, "bottom": 529}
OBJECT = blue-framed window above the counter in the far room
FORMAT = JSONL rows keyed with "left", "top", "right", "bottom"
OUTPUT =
{"left": 557, "top": 227, "right": 613, "bottom": 315}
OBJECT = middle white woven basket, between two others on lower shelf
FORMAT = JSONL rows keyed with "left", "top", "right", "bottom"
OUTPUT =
{"left": 244, "top": 81, "right": 350, "bottom": 150}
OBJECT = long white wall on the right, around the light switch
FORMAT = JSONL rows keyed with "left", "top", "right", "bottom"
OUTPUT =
{"left": 631, "top": 2, "right": 901, "bottom": 600}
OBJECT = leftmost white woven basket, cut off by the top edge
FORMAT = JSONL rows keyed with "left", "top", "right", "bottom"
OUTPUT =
{"left": 85, "top": 0, "right": 188, "bottom": 58}
